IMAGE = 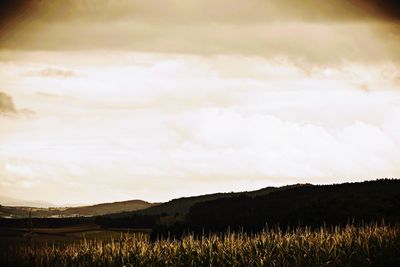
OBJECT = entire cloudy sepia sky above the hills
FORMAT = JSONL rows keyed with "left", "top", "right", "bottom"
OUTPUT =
{"left": 0, "top": 0, "right": 400, "bottom": 205}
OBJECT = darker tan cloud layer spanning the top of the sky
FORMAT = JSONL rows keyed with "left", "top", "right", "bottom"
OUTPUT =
{"left": 0, "top": 0, "right": 400, "bottom": 64}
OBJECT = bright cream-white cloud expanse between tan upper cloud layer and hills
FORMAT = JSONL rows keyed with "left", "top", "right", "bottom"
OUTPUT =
{"left": 0, "top": 53, "right": 400, "bottom": 204}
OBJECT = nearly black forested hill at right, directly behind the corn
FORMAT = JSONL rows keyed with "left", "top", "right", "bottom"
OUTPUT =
{"left": 186, "top": 179, "right": 400, "bottom": 231}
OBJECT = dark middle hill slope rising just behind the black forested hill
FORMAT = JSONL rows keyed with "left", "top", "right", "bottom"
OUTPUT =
{"left": 110, "top": 184, "right": 312, "bottom": 217}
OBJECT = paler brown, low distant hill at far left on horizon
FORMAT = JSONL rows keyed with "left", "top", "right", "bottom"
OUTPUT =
{"left": 0, "top": 200, "right": 158, "bottom": 218}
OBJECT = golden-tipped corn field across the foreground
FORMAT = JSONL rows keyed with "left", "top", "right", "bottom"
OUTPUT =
{"left": 0, "top": 225, "right": 400, "bottom": 266}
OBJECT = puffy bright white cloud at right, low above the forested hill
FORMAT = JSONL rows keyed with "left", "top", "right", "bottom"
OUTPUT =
{"left": 173, "top": 109, "right": 399, "bottom": 182}
